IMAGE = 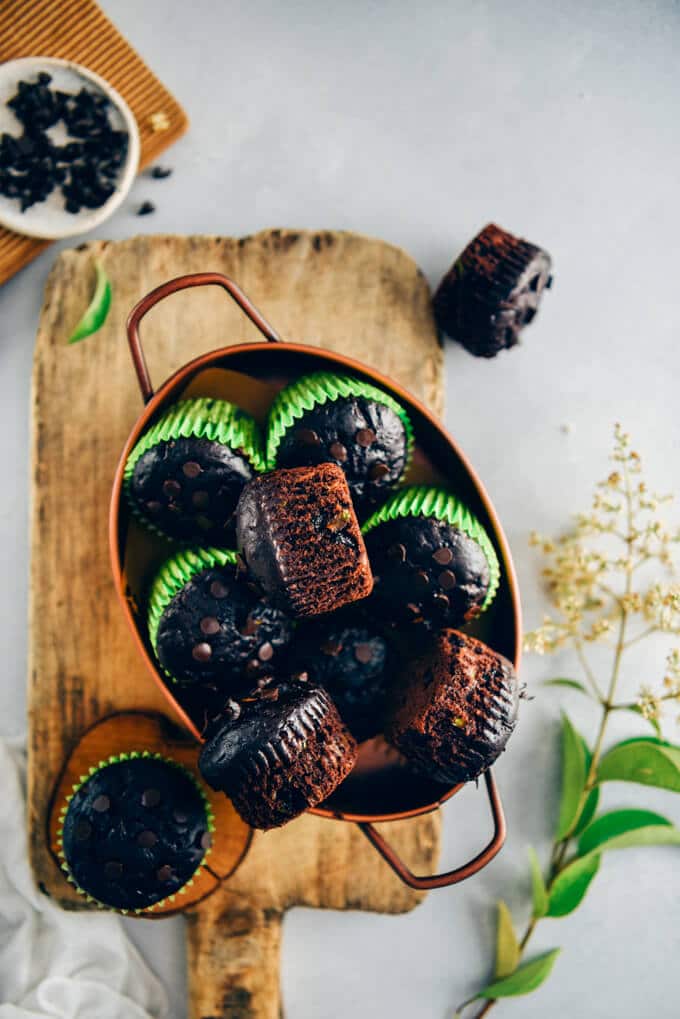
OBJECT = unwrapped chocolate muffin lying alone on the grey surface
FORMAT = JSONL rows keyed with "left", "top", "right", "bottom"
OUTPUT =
{"left": 433, "top": 223, "right": 553, "bottom": 358}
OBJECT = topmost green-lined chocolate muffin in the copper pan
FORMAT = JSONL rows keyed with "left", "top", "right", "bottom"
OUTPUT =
{"left": 267, "top": 372, "right": 413, "bottom": 508}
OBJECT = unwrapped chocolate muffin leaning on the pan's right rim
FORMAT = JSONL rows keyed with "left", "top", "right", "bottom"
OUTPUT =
{"left": 385, "top": 630, "right": 519, "bottom": 785}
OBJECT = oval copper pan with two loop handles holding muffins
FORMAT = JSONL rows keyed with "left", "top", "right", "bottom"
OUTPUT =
{"left": 109, "top": 273, "right": 521, "bottom": 889}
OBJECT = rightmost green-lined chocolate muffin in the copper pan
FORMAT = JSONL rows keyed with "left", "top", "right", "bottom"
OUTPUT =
{"left": 363, "top": 486, "right": 500, "bottom": 630}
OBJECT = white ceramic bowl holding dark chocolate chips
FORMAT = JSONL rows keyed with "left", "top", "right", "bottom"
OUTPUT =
{"left": 0, "top": 57, "right": 140, "bottom": 240}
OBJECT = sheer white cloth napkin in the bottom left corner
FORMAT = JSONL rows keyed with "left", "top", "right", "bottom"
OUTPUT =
{"left": 0, "top": 740, "right": 167, "bottom": 1019}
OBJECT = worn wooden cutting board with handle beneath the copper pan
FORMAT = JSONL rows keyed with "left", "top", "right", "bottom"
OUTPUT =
{"left": 29, "top": 230, "right": 442, "bottom": 1019}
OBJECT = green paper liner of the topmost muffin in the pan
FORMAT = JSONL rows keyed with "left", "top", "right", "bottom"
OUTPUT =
{"left": 266, "top": 372, "right": 413, "bottom": 474}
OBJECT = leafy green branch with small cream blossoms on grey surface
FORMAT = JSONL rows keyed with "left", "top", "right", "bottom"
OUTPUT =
{"left": 456, "top": 425, "right": 680, "bottom": 1019}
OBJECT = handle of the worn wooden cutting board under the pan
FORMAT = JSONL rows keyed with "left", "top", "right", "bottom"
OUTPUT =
{"left": 187, "top": 886, "right": 283, "bottom": 1019}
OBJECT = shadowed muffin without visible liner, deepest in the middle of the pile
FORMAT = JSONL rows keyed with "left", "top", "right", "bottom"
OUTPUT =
{"left": 291, "top": 619, "right": 391, "bottom": 743}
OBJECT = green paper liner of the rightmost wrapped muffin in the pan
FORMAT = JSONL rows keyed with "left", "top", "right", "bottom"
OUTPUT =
{"left": 361, "top": 485, "right": 501, "bottom": 611}
